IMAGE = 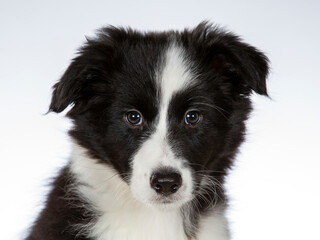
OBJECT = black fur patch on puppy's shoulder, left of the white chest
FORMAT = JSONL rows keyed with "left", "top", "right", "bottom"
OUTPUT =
{"left": 27, "top": 167, "right": 94, "bottom": 240}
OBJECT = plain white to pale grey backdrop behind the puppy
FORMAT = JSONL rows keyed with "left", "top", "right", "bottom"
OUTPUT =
{"left": 0, "top": 0, "right": 320, "bottom": 240}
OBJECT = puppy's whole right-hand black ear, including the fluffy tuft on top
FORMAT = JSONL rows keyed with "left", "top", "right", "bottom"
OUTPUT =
{"left": 192, "top": 22, "right": 269, "bottom": 96}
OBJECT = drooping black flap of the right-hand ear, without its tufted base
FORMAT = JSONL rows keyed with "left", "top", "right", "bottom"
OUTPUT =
{"left": 211, "top": 37, "right": 269, "bottom": 96}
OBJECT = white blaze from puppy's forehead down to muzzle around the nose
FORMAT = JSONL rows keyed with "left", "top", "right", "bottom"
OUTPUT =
{"left": 130, "top": 44, "right": 193, "bottom": 206}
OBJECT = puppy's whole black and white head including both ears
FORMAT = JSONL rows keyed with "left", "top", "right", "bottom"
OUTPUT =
{"left": 50, "top": 23, "right": 268, "bottom": 210}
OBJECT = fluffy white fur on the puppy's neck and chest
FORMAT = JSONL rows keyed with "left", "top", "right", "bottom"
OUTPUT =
{"left": 71, "top": 144, "right": 229, "bottom": 240}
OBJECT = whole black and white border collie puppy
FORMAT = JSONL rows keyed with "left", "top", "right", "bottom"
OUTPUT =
{"left": 27, "top": 22, "right": 268, "bottom": 240}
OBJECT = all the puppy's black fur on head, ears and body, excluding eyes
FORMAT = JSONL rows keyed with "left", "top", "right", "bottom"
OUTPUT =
{"left": 28, "top": 23, "right": 268, "bottom": 240}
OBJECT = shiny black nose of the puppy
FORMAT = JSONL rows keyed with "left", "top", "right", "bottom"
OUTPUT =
{"left": 150, "top": 171, "right": 182, "bottom": 196}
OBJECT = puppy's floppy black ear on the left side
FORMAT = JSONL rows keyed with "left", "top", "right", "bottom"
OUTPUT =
{"left": 49, "top": 38, "right": 113, "bottom": 113}
